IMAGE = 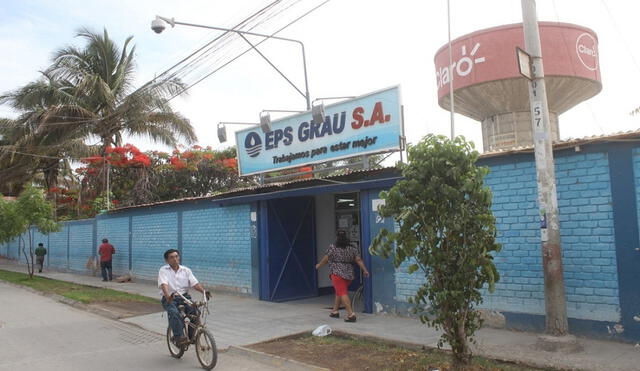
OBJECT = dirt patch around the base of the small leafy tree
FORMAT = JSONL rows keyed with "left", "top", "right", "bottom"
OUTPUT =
{"left": 249, "top": 335, "right": 552, "bottom": 371}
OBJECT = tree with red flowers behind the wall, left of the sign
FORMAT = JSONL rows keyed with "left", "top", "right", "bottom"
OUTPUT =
{"left": 65, "top": 144, "right": 244, "bottom": 216}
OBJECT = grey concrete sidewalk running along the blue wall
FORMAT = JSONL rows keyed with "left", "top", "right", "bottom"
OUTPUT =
{"left": 0, "top": 259, "right": 640, "bottom": 371}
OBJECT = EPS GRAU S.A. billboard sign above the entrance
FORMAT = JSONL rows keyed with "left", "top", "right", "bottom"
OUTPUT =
{"left": 236, "top": 86, "right": 402, "bottom": 176}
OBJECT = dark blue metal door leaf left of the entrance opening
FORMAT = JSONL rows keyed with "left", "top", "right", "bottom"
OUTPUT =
{"left": 267, "top": 197, "right": 318, "bottom": 301}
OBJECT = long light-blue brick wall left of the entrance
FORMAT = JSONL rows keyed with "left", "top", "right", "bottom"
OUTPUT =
{"left": 0, "top": 202, "right": 258, "bottom": 295}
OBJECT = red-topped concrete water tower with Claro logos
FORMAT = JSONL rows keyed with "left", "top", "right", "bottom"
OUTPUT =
{"left": 435, "top": 22, "right": 602, "bottom": 151}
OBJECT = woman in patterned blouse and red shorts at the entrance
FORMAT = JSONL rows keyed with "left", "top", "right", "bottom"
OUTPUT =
{"left": 316, "top": 229, "right": 369, "bottom": 322}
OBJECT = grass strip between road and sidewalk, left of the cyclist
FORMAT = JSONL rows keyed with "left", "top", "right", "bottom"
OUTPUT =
{"left": 0, "top": 269, "right": 158, "bottom": 304}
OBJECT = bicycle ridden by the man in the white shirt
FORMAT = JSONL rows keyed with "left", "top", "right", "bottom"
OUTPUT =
{"left": 167, "top": 293, "right": 218, "bottom": 370}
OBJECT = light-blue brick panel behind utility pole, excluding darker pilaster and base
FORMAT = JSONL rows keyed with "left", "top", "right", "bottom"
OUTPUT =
{"left": 485, "top": 153, "right": 620, "bottom": 322}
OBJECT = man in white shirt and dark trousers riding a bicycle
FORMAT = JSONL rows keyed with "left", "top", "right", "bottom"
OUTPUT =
{"left": 158, "top": 249, "right": 205, "bottom": 345}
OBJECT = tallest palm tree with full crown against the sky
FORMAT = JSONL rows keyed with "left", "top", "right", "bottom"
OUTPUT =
{"left": 47, "top": 28, "right": 196, "bottom": 151}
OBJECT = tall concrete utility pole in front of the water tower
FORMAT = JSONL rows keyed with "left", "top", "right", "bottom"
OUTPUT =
{"left": 521, "top": 0, "right": 569, "bottom": 336}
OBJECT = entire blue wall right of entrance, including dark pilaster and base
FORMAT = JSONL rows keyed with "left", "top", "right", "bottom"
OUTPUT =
{"left": 369, "top": 144, "right": 640, "bottom": 339}
